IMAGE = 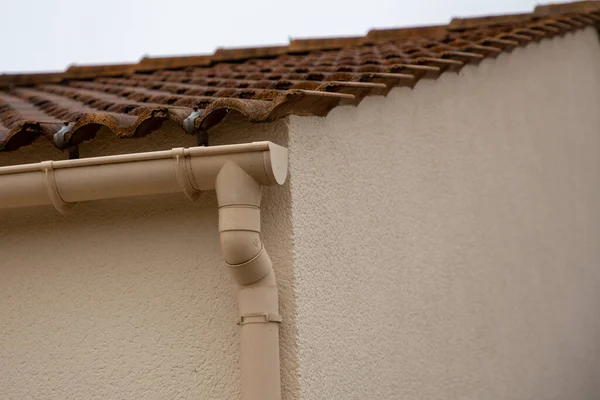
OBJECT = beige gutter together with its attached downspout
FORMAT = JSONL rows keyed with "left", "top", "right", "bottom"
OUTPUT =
{"left": 0, "top": 142, "right": 287, "bottom": 400}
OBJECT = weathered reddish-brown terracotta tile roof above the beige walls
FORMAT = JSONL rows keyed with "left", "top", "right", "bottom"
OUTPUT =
{"left": 0, "top": 1, "right": 600, "bottom": 151}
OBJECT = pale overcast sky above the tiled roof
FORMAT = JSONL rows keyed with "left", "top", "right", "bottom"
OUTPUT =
{"left": 0, "top": 0, "right": 546, "bottom": 72}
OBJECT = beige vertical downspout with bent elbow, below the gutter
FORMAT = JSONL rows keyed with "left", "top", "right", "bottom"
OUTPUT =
{"left": 215, "top": 162, "right": 281, "bottom": 400}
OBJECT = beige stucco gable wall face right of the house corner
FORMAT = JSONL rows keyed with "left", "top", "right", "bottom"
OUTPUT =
{"left": 289, "top": 29, "right": 600, "bottom": 400}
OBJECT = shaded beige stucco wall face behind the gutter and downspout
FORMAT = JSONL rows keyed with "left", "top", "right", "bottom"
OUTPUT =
{"left": 0, "top": 121, "right": 297, "bottom": 400}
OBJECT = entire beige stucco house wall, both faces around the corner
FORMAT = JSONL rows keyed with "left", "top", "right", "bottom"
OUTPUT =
{"left": 0, "top": 26, "right": 600, "bottom": 400}
